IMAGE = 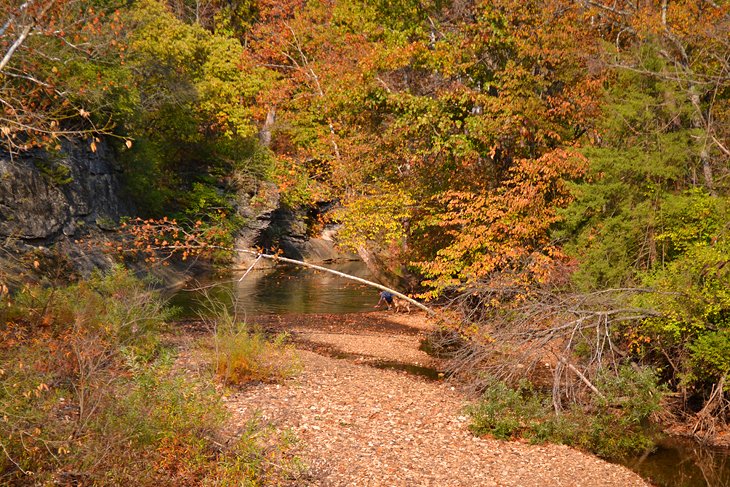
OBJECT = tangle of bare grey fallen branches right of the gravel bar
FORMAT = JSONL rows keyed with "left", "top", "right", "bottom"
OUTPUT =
{"left": 438, "top": 285, "right": 659, "bottom": 411}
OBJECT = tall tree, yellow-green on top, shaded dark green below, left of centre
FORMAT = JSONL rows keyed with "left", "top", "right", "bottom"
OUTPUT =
{"left": 119, "top": 0, "right": 271, "bottom": 223}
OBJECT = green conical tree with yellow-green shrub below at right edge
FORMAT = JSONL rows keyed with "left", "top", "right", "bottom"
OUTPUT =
{"left": 554, "top": 35, "right": 730, "bottom": 395}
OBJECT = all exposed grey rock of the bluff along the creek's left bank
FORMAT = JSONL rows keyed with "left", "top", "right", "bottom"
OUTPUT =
{"left": 0, "top": 141, "right": 357, "bottom": 281}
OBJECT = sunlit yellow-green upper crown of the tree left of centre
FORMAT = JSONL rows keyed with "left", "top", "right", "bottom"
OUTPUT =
{"left": 130, "top": 0, "right": 258, "bottom": 138}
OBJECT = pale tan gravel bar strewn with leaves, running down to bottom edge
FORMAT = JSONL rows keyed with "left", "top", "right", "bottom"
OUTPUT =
{"left": 218, "top": 313, "right": 649, "bottom": 487}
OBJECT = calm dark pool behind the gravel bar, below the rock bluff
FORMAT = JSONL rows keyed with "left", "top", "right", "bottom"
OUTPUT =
{"left": 171, "top": 262, "right": 378, "bottom": 317}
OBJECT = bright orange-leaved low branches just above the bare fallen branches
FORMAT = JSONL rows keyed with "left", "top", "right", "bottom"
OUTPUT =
{"left": 417, "top": 149, "right": 586, "bottom": 304}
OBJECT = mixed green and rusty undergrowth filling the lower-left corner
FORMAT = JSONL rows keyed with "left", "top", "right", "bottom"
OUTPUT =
{"left": 0, "top": 268, "right": 297, "bottom": 486}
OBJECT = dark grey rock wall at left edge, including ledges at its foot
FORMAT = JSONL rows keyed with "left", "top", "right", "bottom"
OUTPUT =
{"left": 0, "top": 141, "right": 134, "bottom": 287}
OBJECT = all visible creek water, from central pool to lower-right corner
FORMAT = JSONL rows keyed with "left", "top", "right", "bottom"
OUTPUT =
{"left": 171, "top": 262, "right": 730, "bottom": 487}
